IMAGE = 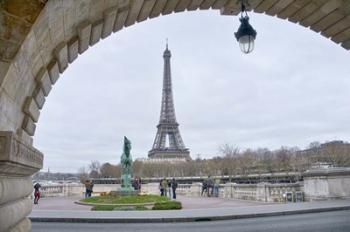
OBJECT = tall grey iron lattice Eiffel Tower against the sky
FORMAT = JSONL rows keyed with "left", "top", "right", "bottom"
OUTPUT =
{"left": 148, "top": 43, "right": 191, "bottom": 160}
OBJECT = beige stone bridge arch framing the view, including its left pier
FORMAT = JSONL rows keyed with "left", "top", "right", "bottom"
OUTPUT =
{"left": 0, "top": 0, "right": 350, "bottom": 231}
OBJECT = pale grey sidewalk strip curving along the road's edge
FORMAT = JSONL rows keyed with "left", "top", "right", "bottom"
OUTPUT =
{"left": 29, "top": 198, "right": 350, "bottom": 223}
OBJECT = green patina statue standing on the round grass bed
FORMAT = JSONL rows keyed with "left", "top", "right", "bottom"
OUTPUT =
{"left": 120, "top": 136, "right": 133, "bottom": 191}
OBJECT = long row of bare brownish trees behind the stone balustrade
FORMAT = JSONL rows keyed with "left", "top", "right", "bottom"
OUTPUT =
{"left": 79, "top": 141, "right": 350, "bottom": 181}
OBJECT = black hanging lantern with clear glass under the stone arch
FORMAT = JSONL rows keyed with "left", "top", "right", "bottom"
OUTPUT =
{"left": 235, "top": 0, "right": 256, "bottom": 54}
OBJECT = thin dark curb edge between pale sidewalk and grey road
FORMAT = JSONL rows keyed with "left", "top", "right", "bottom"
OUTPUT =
{"left": 29, "top": 206, "right": 350, "bottom": 223}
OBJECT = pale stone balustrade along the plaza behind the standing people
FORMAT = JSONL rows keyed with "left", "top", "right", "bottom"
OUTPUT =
{"left": 31, "top": 168, "right": 350, "bottom": 203}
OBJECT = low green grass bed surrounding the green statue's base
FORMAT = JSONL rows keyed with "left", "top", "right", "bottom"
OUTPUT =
{"left": 80, "top": 195, "right": 170, "bottom": 204}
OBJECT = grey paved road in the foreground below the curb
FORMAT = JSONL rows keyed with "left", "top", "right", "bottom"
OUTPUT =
{"left": 32, "top": 210, "right": 350, "bottom": 232}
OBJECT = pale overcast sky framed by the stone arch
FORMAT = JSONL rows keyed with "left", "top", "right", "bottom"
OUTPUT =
{"left": 34, "top": 11, "right": 350, "bottom": 172}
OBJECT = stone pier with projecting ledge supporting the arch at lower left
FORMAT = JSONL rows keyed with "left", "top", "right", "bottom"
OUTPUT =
{"left": 0, "top": 131, "right": 43, "bottom": 232}
